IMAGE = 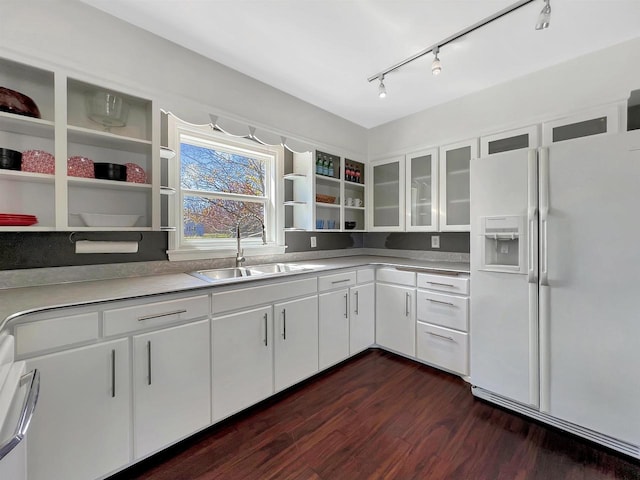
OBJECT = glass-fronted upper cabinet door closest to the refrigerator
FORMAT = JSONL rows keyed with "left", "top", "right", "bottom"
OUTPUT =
{"left": 440, "top": 139, "right": 478, "bottom": 232}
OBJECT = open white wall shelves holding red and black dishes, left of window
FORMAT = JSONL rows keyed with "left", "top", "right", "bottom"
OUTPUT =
{"left": 0, "top": 54, "right": 160, "bottom": 231}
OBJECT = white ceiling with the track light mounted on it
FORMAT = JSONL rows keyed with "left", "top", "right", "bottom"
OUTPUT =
{"left": 80, "top": 0, "right": 640, "bottom": 128}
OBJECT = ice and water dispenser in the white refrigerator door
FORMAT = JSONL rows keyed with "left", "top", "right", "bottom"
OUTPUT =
{"left": 480, "top": 215, "right": 527, "bottom": 273}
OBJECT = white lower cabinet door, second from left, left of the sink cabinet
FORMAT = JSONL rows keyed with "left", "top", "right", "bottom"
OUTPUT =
{"left": 133, "top": 320, "right": 211, "bottom": 458}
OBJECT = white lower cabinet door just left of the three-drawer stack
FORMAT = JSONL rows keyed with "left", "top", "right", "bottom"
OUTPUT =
{"left": 376, "top": 284, "right": 416, "bottom": 357}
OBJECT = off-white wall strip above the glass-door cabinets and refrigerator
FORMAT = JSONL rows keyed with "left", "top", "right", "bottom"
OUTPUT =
{"left": 369, "top": 38, "right": 640, "bottom": 159}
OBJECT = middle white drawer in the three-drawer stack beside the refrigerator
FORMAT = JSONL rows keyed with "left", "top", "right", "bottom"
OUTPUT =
{"left": 416, "top": 290, "right": 469, "bottom": 332}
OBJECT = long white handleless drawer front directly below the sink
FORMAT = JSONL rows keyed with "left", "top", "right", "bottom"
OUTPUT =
{"left": 212, "top": 277, "right": 318, "bottom": 314}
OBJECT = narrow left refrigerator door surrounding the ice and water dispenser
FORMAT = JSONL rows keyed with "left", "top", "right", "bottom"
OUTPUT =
{"left": 470, "top": 150, "right": 538, "bottom": 407}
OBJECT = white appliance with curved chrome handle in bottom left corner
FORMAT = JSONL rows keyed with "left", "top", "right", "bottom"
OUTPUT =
{"left": 0, "top": 335, "right": 40, "bottom": 480}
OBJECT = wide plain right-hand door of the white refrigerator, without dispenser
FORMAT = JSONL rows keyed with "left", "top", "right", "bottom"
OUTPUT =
{"left": 540, "top": 134, "right": 640, "bottom": 444}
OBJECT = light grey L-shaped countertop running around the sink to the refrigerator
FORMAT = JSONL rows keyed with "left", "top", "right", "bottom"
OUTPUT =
{"left": 0, "top": 255, "right": 470, "bottom": 331}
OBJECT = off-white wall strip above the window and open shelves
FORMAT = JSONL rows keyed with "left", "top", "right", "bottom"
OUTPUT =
{"left": 0, "top": 0, "right": 367, "bottom": 156}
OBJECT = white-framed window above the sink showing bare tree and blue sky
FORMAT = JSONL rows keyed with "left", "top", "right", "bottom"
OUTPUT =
{"left": 168, "top": 116, "right": 284, "bottom": 260}
